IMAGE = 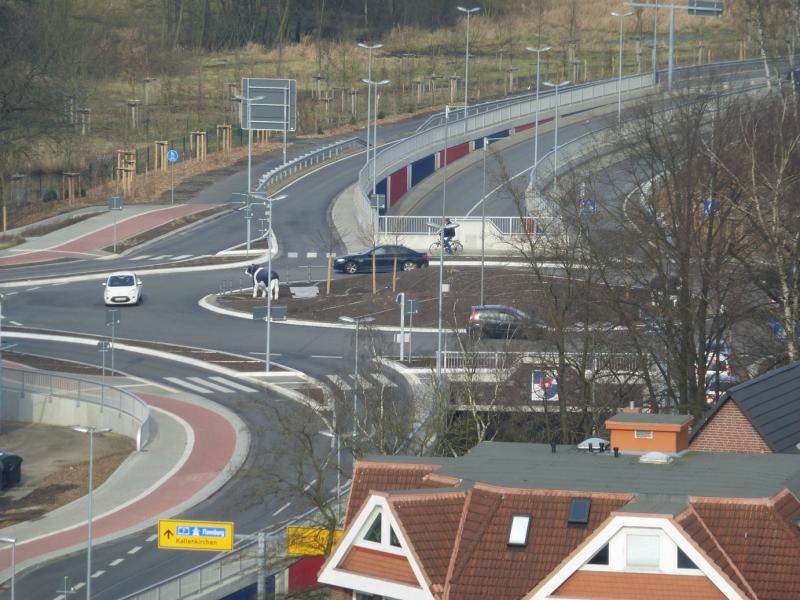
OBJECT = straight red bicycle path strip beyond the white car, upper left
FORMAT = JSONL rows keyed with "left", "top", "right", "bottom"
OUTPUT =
{"left": 0, "top": 204, "right": 216, "bottom": 266}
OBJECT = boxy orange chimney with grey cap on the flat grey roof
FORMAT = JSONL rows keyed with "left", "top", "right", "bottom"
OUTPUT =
{"left": 605, "top": 410, "right": 694, "bottom": 454}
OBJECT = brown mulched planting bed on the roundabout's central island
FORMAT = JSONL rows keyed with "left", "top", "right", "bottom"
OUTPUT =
{"left": 216, "top": 266, "right": 644, "bottom": 328}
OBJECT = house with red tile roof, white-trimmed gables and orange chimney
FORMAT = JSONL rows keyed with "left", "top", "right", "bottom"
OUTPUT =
{"left": 319, "top": 414, "right": 800, "bottom": 600}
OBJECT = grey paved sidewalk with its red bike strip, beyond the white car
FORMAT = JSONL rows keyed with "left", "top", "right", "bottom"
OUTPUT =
{"left": 0, "top": 203, "right": 217, "bottom": 266}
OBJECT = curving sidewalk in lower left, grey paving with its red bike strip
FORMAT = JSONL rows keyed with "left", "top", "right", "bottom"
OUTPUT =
{"left": 0, "top": 378, "right": 250, "bottom": 581}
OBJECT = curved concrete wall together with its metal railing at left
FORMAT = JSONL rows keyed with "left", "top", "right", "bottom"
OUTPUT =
{"left": 2, "top": 366, "right": 150, "bottom": 450}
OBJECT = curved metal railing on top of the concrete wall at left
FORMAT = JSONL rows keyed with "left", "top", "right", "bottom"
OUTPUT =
{"left": 2, "top": 366, "right": 150, "bottom": 450}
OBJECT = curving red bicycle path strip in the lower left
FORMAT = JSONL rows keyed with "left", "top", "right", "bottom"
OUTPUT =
{"left": 0, "top": 393, "right": 236, "bottom": 570}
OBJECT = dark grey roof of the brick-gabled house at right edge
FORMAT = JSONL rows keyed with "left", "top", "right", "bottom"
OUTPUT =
{"left": 692, "top": 362, "right": 800, "bottom": 452}
